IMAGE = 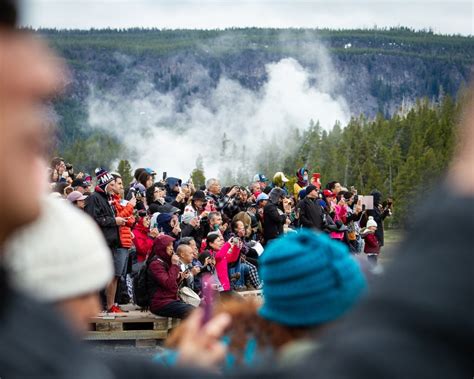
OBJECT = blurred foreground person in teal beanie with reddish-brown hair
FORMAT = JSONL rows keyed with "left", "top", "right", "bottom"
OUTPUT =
{"left": 160, "top": 230, "right": 367, "bottom": 377}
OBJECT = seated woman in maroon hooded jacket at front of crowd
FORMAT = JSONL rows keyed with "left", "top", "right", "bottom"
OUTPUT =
{"left": 148, "top": 234, "right": 194, "bottom": 319}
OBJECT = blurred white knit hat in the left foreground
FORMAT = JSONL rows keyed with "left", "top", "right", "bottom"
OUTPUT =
{"left": 5, "top": 198, "right": 113, "bottom": 302}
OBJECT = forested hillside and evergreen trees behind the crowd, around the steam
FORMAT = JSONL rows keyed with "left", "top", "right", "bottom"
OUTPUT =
{"left": 39, "top": 28, "right": 474, "bottom": 226}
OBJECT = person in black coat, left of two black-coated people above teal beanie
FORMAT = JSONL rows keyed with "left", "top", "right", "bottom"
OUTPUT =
{"left": 263, "top": 187, "right": 287, "bottom": 244}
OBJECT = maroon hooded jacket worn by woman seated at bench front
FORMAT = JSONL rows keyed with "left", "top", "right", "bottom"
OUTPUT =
{"left": 148, "top": 235, "right": 180, "bottom": 313}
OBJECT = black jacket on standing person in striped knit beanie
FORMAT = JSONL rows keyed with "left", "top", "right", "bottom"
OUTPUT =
{"left": 85, "top": 191, "right": 120, "bottom": 249}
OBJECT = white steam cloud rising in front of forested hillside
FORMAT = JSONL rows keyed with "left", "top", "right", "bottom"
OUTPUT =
{"left": 88, "top": 54, "right": 350, "bottom": 179}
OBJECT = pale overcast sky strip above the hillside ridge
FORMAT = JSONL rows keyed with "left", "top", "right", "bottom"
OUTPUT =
{"left": 22, "top": 0, "right": 474, "bottom": 35}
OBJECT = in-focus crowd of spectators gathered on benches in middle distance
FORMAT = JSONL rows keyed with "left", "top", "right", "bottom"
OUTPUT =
{"left": 44, "top": 157, "right": 392, "bottom": 318}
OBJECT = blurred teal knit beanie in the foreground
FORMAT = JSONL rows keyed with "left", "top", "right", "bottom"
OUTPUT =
{"left": 259, "top": 229, "right": 366, "bottom": 326}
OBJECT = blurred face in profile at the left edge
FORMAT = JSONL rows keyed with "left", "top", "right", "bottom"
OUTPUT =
{"left": 0, "top": 0, "right": 66, "bottom": 247}
